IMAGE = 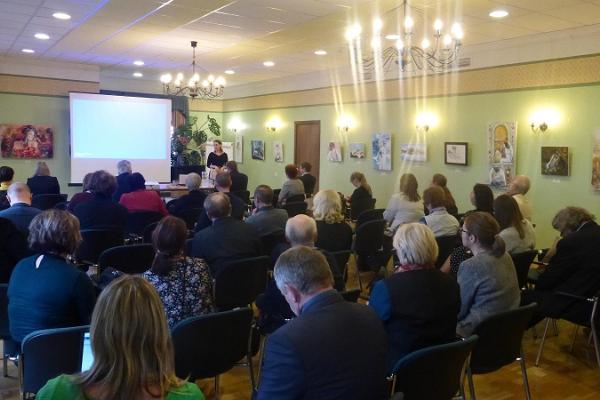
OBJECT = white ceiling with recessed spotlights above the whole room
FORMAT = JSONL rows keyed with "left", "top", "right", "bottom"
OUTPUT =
{"left": 0, "top": 0, "right": 600, "bottom": 85}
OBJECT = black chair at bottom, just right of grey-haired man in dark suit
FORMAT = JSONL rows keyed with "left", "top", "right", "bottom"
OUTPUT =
{"left": 388, "top": 335, "right": 477, "bottom": 400}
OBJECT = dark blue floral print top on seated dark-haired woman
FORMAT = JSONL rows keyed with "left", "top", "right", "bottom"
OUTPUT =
{"left": 144, "top": 257, "right": 213, "bottom": 329}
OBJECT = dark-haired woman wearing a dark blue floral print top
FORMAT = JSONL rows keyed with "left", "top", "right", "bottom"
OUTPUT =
{"left": 144, "top": 216, "right": 212, "bottom": 329}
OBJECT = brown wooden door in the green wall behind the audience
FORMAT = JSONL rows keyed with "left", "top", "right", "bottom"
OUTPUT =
{"left": 294, "top": 121, "right": 321, "bottom": 193}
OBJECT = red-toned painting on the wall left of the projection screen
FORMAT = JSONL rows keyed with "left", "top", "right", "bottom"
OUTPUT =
{"left": 0, "top": 124, "right": 54, "bottom": 158}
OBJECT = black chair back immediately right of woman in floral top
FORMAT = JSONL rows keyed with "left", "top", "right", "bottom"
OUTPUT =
{"left": 213, "top": 256, "right": 271, "bottom": 310}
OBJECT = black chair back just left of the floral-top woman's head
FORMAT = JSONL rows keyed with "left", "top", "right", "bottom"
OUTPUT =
{"left": 98, "top": 244, "right": 154, "bottom": 274}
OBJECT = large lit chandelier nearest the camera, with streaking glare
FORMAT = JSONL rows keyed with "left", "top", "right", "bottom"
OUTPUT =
{"left": 346, "top": 0, "right": 463, "bottom": 74}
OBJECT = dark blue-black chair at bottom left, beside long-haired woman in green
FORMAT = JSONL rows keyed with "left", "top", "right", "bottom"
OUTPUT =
{"left": 19, "top": 326, "right": 90, "bottom": 399}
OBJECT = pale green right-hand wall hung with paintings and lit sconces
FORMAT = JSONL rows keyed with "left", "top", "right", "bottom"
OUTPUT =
{"left": 223, "top": 85, "right": 600, "bottom": 246}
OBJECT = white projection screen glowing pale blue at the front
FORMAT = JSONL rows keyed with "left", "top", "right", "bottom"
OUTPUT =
{"left": 69, "top": 93, "right": 171, "bottom": 183}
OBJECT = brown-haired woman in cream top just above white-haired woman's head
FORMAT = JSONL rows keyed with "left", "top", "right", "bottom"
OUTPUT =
{"left": 383, "top": 174, "right": 425, "bottom": 230}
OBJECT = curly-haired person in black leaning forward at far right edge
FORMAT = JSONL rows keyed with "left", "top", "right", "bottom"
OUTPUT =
{"left": 523, "top": 207, "right": 600, "bottom": 325}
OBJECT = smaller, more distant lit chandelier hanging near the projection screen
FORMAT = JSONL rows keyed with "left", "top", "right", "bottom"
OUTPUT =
{"left": 160, "top": 41, "right": 225, "bottom": 99}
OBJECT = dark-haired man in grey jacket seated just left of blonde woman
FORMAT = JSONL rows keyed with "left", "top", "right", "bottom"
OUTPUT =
{"left": 246, "top": 185, "right": 288, "bottom": 237}
